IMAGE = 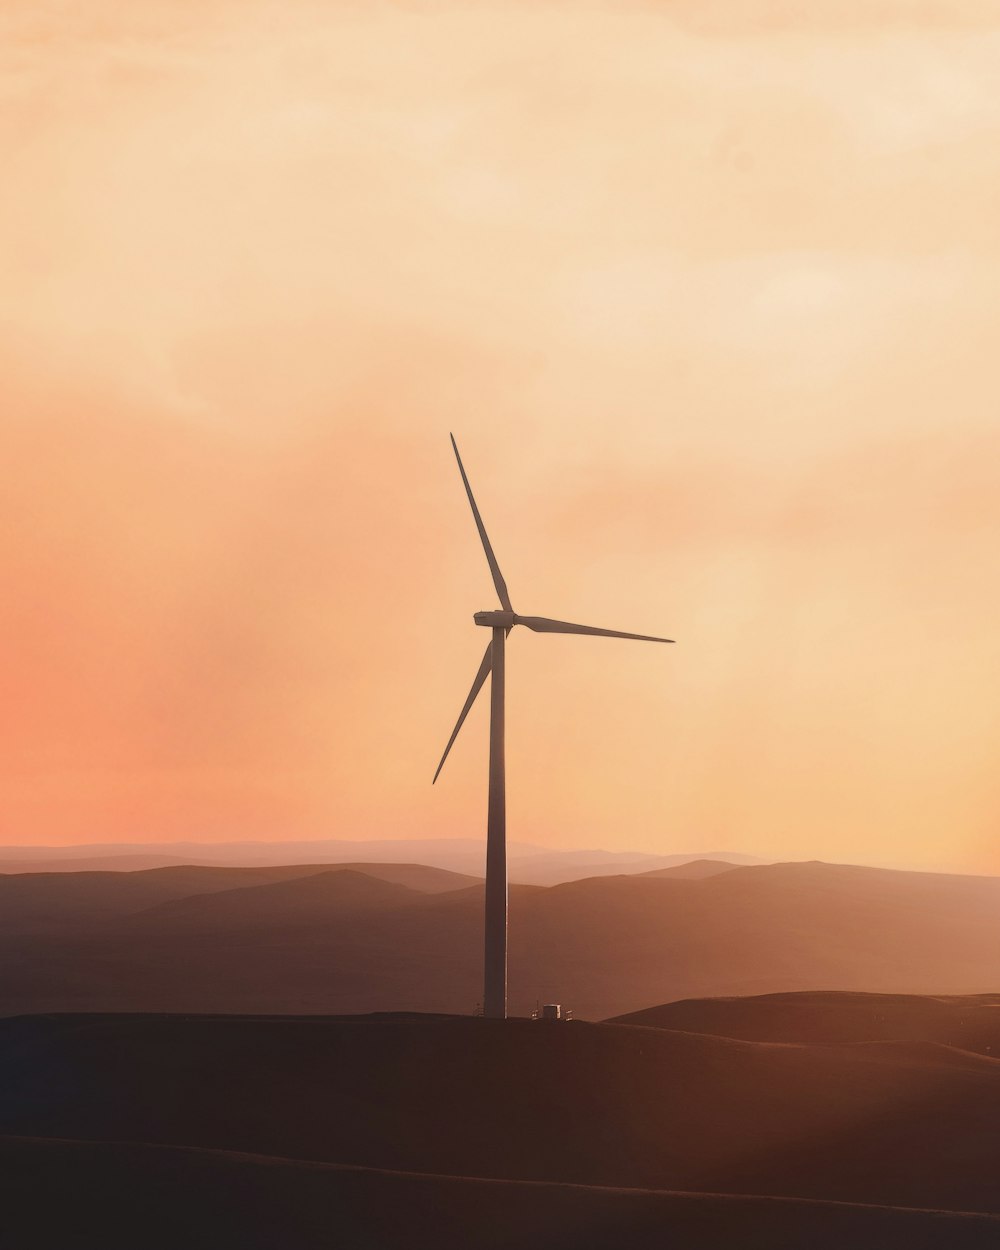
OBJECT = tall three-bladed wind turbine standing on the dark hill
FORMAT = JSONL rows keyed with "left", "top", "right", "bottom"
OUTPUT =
{"left": 431, "top": 434, "right": 674, "bottom": 1020}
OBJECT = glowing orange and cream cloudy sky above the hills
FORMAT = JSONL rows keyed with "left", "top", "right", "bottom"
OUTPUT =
{"left": 0, "top": 0, "right": 1000, "bottom": 871}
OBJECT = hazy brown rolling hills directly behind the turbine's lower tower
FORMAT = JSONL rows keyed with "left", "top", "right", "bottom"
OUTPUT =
{"left": 0, "top": 864, "right": 1000, "bottom": 1025}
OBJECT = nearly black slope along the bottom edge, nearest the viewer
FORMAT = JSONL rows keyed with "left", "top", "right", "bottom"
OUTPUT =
{"left": 0, "top": 1138, "right": 1000, "bottom": 1250}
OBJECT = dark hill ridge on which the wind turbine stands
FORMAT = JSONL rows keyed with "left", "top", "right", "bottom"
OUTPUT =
{"left": 0, "top": 1016, "right": 1000, "bottom": 1215}
